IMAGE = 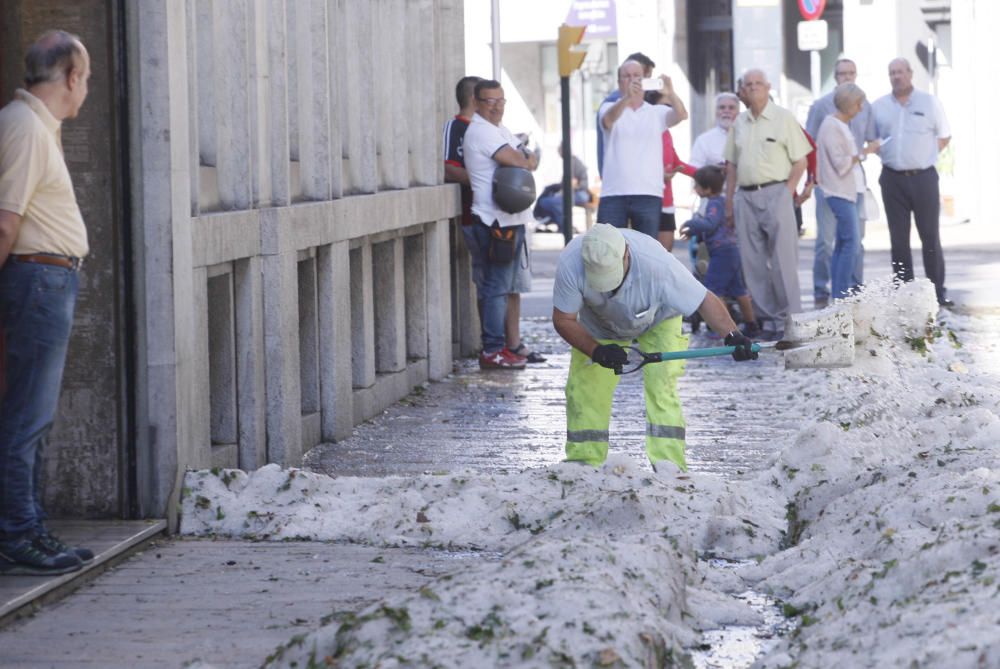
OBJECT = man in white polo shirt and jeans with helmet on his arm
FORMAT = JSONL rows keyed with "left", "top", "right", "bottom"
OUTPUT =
{"left": 463, "top": 79, "right": 538, "bottom": 369}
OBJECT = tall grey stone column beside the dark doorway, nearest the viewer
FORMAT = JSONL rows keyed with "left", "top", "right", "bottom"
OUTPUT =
{"left": 126, "top": 0, "right": 197, "bottom": 527}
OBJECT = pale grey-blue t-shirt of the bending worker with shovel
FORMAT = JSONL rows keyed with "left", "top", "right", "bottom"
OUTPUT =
{"left": 552, "top": 229, "right": 706, "bottom": 339}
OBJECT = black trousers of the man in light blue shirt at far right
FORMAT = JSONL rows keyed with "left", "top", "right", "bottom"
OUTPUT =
{"left": 878, "top": 167, "right": 945, "bottom": 302}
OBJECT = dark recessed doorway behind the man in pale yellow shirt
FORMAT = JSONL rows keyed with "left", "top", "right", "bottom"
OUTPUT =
{"left": 0, "top": 0, "right": 134, "bottom": 518}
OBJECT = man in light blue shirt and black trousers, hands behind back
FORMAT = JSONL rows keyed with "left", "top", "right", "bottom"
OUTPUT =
{"left": 872, "top": 58, "right": 954, "bottom": 307}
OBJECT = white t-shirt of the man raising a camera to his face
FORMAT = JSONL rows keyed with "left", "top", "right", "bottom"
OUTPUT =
{"left": 597, "top": 102, "right": 677, "bottom": 198}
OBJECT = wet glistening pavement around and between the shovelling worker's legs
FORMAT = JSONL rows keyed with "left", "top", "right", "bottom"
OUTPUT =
{"left": 304, "top": 318, "right": 805, "bottom": 476}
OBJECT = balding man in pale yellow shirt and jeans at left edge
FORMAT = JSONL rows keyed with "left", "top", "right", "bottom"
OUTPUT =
{"left": 0, "top": 30, "right": 94, "bottom": 575}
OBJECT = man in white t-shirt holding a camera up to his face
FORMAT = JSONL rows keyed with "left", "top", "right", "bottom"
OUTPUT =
{"left": 597, "top": 60, "right": 688, "bottom": 238}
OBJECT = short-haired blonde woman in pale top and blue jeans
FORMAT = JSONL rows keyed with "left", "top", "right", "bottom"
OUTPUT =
{"left": 816, "top": 84, "right": 878, "bottom": 299}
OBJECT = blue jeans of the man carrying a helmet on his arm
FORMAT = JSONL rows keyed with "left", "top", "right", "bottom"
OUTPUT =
{"left": 469, "top": 217, "right": 524, "bottom": 353}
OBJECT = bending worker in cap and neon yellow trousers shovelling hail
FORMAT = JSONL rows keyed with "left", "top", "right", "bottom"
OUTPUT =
{"left": 552, "top": 223, "right": 757, "bottom": 470}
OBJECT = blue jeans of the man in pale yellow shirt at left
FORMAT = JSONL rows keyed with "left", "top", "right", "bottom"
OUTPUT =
{"left": 0, "top": 259, "right": 79, "bottom": 539}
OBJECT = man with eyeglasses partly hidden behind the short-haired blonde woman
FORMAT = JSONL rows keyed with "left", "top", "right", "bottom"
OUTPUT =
{"left": 806, "top": 58, "right": 877, "bottom": 309}
